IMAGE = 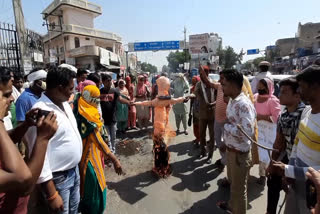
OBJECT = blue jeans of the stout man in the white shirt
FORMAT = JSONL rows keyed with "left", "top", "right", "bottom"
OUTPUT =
{"left": 52, "top": 166, "right": 80, "bottom": 214}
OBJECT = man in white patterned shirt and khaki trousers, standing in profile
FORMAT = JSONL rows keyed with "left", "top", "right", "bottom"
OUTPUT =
{"left": 217, "top": 69, "right": 256, "bottom": 214}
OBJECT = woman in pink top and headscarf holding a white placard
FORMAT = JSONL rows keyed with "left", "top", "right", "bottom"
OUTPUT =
{"left": 254, "top": 77, "right": 281, "bottom": 185}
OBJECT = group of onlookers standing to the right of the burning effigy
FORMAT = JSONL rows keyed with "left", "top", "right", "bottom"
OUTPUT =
{"left": 191, "top": 61, "right": 320, "bottom": 214}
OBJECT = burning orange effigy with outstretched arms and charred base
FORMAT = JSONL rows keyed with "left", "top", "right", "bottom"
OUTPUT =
{"left": 134, "top": 77, "right": 189, "bottom": 178}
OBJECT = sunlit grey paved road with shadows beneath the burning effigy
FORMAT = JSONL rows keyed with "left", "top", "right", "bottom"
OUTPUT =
{"left": 105, "top": 111, "right": 282, "bottom": 214}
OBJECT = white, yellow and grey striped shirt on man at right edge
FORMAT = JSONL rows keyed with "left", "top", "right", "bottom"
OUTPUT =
{"left": 285, "top": 108, "right": 320, "bottom": 180}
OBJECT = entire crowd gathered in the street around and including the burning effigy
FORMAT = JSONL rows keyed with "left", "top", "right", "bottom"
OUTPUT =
{"left": 0, "top": 61, "right": 320, "bottom": 214}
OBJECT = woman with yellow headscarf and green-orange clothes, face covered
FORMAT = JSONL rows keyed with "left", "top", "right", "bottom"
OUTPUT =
{"left": 74, "top": 85, "right": 122, "bottom": 214}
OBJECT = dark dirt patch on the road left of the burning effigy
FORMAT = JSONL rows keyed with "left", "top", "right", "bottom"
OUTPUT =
{"left": 116, "top": 140, "right": 142, "bottom": 157}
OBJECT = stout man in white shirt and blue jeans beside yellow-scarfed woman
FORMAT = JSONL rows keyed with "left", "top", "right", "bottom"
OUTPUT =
{"left": 27, "top": 67, "right": 82, "bottom": 214}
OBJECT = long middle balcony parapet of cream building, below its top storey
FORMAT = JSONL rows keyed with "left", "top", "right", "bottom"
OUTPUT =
{"left": 43, "top": 24, "right": 121, "bottom": 42}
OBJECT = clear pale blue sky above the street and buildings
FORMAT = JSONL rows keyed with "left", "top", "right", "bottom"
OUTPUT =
{"left": 0, "top": 0, "right": 320, "bottom": 67}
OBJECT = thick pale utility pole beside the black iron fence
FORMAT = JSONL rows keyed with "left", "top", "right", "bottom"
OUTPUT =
{"left": 12, "top": 0, "right": 28, "bottom": 73}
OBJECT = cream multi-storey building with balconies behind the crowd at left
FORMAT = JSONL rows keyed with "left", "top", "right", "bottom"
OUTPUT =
{"left": 42, "top": 0, "right": 123, "bottom": 70}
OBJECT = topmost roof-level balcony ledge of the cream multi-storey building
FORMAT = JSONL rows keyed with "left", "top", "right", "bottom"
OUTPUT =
{"left": 42, "top": 0, "right": 102, "bottom": 17}
